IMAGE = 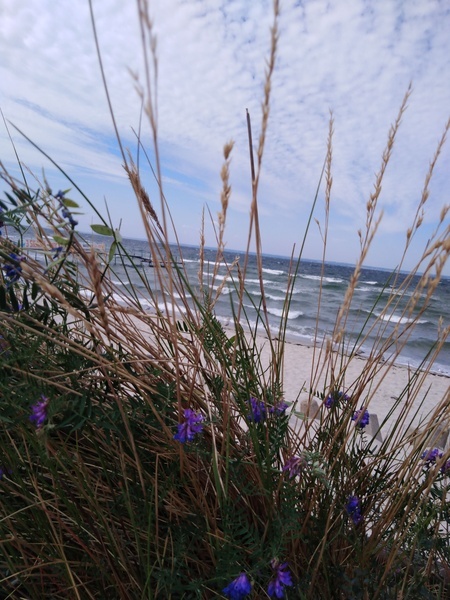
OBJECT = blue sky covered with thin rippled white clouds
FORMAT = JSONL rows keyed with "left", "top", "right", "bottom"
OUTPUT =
{"left": 0, "top": 0, "right": 450, "bottom": 273}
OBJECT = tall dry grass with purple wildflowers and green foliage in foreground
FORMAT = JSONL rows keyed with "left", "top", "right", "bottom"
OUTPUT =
{"left": 0, "top": 2, "right": 450, "bottom": 600}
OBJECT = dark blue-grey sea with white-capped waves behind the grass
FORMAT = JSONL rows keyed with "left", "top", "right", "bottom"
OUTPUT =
{"left": 19, "top": 235, "right": 450, "bottom": 376}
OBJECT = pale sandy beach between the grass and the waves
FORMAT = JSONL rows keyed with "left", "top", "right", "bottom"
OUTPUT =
{"left": 110, "top": 315, "right": 450, "bottom": 447}
